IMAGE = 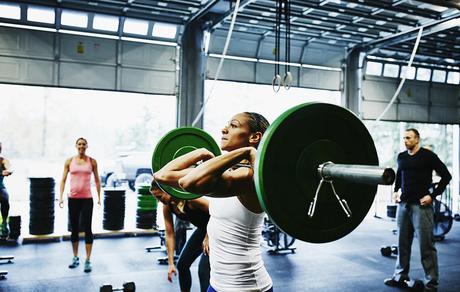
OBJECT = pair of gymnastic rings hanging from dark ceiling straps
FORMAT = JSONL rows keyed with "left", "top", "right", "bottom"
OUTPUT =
{"left": 272, "top": 0, "right": 292, "bottom": 92}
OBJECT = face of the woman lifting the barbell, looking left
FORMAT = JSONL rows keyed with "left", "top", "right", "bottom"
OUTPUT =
{"left": 220, "top": 113, "right": 251, "bottom": 151}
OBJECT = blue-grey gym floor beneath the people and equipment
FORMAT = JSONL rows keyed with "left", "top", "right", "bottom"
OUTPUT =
{"left": 0, "top": 215, "right": 460, "bottom": 292}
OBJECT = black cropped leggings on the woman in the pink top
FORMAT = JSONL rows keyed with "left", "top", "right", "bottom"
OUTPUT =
{"left": 69, "top": 198, "right": 94, "bottom": 243}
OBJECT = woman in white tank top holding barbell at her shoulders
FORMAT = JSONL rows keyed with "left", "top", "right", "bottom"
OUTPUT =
{"left": 154, "top": 112, "right": 273, "bottom": 292}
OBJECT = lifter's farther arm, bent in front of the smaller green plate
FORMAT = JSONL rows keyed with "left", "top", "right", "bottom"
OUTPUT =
{"left": 154, "top": 148, "right": 214, "bottom": 187}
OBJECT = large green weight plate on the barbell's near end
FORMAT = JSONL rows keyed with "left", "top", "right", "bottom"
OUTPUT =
{"left": 254, "top": 103, "right": 378, "bottom": 243}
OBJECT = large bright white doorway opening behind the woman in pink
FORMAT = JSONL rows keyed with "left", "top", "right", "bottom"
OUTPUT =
{"left": 0, "top": 84, "right": 176, "bottom": 207}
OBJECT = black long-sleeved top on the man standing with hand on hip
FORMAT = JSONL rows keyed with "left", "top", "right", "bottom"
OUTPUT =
{"left": 395, "top": 148, "right": 452, "bottom": 203}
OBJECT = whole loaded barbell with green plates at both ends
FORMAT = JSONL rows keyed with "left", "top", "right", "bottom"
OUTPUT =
{"left": 152, "top": 103, "right": 395, "bottom": 243}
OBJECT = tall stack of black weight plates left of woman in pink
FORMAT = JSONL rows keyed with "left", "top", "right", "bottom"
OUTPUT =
{"left": 29, "top": 177, "right": 54, "bottom": 235}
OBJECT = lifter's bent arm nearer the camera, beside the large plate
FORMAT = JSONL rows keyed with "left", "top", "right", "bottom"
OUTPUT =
{"left": 179, "top": 147, "right": 255, "bottom": 197}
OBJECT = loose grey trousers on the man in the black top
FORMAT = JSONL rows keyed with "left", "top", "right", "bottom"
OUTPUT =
{"left": 393, "top": 202, "right": 439, "bottom": 288}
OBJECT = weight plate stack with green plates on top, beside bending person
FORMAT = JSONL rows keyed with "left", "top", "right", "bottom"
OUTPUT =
{"left": 136, "top": 185, "right": 157, "bottom": 229}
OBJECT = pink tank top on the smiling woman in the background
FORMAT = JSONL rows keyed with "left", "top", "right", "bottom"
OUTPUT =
{"left": 69, "top": 157, "right": 93, "bottom": 199}
